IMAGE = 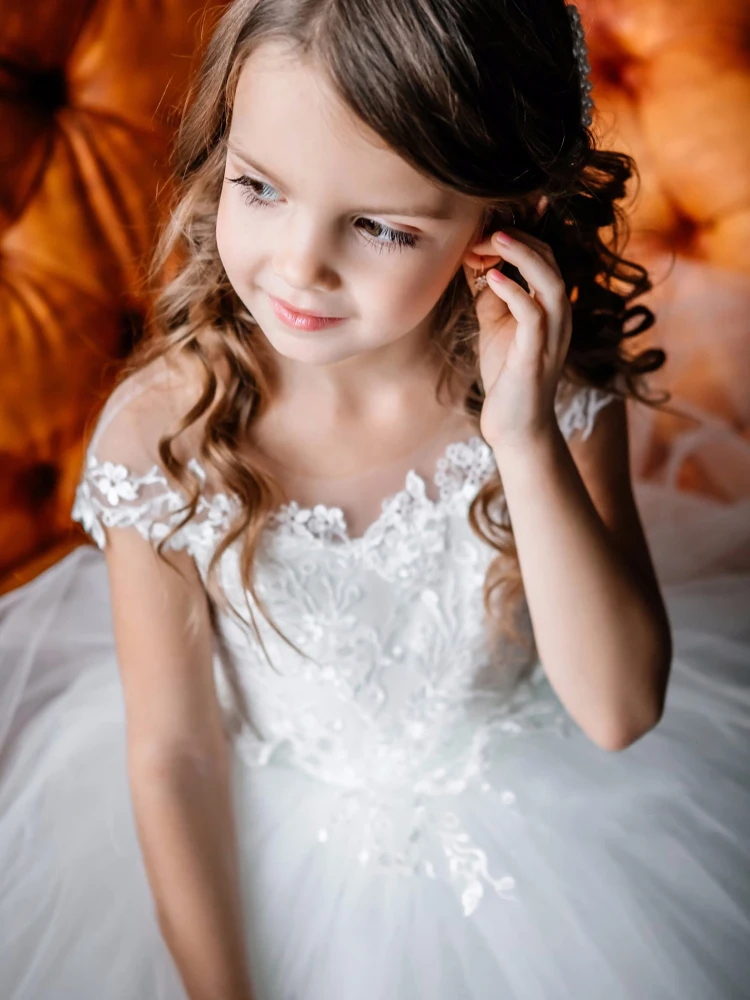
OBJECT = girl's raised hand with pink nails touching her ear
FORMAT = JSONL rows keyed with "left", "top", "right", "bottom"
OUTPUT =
{"left": 464, "top": 226, "right": 573, "bottom": 449}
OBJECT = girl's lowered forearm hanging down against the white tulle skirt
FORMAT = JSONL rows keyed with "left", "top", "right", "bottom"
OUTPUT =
{"left": 129, "top": 753, "right": 252, "bottom": 1000}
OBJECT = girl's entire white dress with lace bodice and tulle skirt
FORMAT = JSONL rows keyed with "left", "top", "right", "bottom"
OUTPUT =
{"left": 0, "top": 362, "right": 750, "bottom": 1000}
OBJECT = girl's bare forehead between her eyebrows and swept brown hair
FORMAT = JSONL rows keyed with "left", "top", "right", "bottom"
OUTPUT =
{"left": 229, "top": 42, "right": 468, "bottom": 217}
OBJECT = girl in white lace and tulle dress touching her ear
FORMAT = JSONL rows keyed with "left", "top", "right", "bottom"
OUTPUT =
{"left": 0, "top": 0, "right": 750, "bottom": 1000}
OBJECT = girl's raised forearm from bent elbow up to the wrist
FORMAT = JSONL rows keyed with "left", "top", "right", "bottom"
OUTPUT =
{"left": 495, "top": 426, "right": 669, "bottom": 748}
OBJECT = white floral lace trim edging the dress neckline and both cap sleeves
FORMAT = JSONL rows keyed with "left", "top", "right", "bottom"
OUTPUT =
{"left": 71, "top": 378, "right": 617, "bottom": 555}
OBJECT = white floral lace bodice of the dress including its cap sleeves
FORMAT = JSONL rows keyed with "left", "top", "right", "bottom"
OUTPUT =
{"left": 72, "top": 368, "right": 613, "bottom": 916}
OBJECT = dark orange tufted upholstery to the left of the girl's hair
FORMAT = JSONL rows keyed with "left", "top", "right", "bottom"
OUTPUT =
{"left": 0, "top": 0, "right": 232, "bottom": 591}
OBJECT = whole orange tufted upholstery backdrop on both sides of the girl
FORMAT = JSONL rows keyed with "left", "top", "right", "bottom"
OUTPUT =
{"left": 0, "top": 0, "right": 750, "bottom": 592}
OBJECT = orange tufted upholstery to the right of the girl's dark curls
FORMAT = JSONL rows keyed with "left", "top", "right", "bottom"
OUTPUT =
{"left": 578, "top": 0, "right": 750, "bottom": 501}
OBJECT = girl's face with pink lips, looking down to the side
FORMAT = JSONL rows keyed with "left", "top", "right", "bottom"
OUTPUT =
{"left": 216, "top": 43, "right": 482, "bottom": 378}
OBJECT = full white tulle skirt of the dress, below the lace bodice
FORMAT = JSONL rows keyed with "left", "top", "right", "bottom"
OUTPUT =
{"left": 0, "top": 484, "right": 750, "bottom": 1000}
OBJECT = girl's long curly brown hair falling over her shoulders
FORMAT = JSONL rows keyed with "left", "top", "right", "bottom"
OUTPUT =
{"left": 114, "top": 0, "right": 669, "bottom": 672}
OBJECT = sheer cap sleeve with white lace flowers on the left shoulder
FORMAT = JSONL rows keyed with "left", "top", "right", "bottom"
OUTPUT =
{"left": 71, "top": 372, "right": 231, "bottom": 552}
